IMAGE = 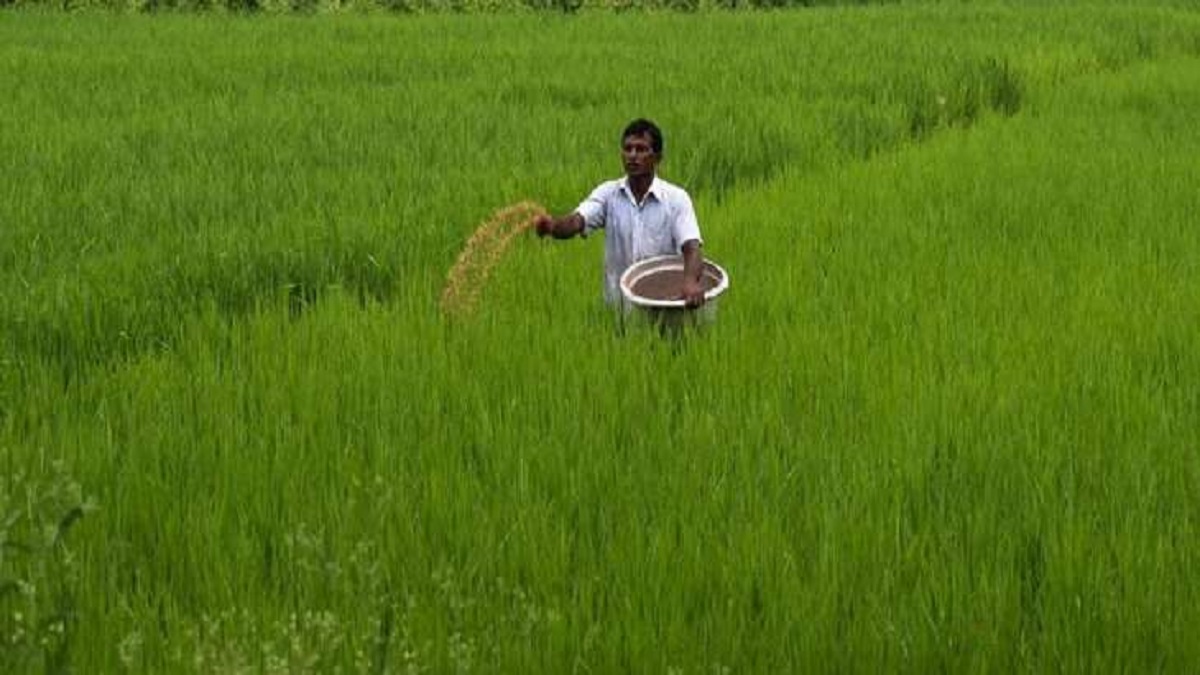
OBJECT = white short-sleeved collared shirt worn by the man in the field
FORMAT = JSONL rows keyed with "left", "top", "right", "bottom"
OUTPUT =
{"left": 575, "top": 177, "right": 702, "bottom": 305}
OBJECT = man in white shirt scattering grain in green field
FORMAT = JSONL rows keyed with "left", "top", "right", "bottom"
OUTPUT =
{"left": 534, "top": 119, "right": 704, "bottom": 307}
